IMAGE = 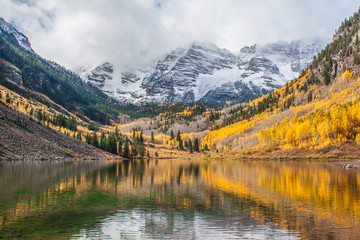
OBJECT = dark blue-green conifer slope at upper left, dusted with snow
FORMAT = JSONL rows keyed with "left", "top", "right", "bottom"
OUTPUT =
{"left": 0, "top": 19, "right": 121, "bottom": 123}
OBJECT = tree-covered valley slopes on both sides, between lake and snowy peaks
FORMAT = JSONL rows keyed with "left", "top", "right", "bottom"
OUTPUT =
{"left": 0, "top": 7, "right": 360, "bottom": 159}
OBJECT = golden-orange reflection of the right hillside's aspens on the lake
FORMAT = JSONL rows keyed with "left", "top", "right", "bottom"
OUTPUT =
{"left": 202, "top": 161, "right": 360, "bottom": 238}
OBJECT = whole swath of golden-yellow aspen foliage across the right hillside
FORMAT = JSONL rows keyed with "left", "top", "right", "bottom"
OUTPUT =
{"left": 202, "top": 70, "right": 360, "bottom": 150}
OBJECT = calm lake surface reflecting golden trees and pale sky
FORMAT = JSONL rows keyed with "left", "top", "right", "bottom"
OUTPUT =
{"left": 0, "top": 159, "right": 360, "bottom": 239}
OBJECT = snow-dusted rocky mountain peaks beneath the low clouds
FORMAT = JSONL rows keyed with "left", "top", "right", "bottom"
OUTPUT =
{"left": 79, "top": 41, "right": 323, "bottom": 106}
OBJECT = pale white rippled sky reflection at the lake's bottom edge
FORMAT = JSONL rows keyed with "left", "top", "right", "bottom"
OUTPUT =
{"left": 71, "top": 209, "right": 298, "bottom": 240}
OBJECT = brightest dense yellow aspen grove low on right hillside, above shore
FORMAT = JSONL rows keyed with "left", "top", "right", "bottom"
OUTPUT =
{"left": 258, "top": 100, "right": 360, "bottom": 148}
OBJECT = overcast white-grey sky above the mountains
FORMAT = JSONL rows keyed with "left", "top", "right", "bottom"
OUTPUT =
{"left": 0, "top": 0, "right": 360, "bottom": 69}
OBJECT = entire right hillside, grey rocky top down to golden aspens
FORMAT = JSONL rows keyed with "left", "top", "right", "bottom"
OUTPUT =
{"left": 202, "top": 8, "right": 360, "bottom": 158}
